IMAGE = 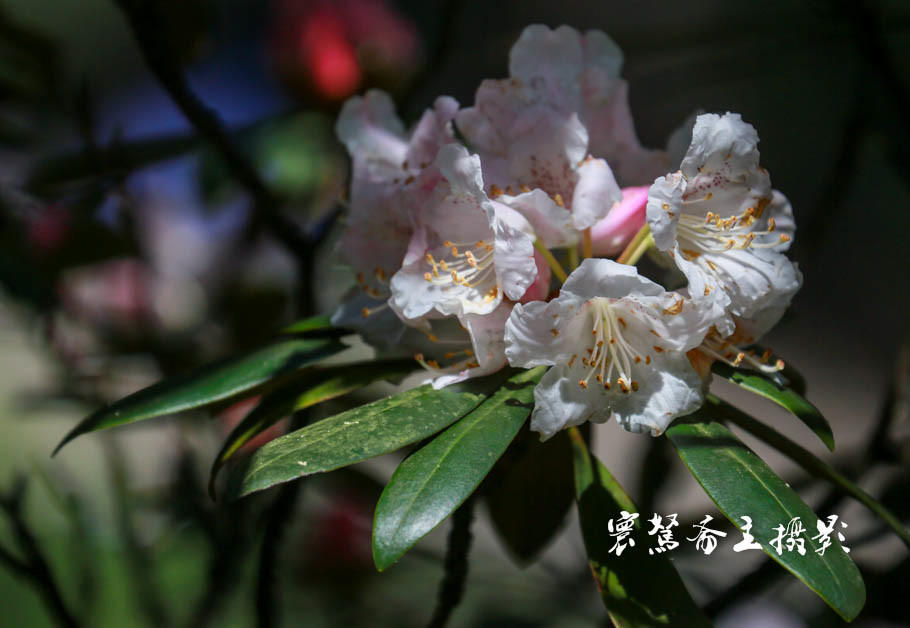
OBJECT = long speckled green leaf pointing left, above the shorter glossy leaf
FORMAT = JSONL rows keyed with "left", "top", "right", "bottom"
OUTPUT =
{"left": 227, "top": 374, "right": 516, "bottom": 498}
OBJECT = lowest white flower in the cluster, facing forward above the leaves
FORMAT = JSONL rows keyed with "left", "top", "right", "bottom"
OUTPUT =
{"left": 505, "top": 259, "right": 713, "bottom": 438}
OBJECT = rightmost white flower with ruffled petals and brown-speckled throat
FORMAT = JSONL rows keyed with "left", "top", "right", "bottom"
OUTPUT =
{"left": 647, "top": 113, "right": 801, "bottom": 336}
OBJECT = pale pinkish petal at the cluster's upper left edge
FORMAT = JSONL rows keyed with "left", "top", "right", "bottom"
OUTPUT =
{"left": 335, "top": 89, "right": 408, "bottom": 180}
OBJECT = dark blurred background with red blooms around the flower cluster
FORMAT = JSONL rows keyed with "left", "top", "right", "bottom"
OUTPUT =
{"left": 0, "top": 0, "right": 910, "bottom": 626}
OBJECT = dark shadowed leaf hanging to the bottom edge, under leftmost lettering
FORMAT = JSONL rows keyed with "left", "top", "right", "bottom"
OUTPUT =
{"left": 569, "top": 428, "right": 711, "bottom": 628}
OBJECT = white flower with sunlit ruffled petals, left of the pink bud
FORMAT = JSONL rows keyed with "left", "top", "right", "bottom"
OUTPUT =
{"left": 390, "top": 144, "right": 537, "bottom": 322}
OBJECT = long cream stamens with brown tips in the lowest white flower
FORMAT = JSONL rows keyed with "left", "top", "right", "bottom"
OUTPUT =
{"left": 569, "top": 297, "right": 657, "bottom": 393}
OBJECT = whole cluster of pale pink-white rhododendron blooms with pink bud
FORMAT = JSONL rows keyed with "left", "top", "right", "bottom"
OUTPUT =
{"left": 333, "top": 25, "right": 802, "bottom": 438}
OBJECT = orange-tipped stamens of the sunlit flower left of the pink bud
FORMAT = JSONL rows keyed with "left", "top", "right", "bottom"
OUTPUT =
{"left": 423, "top": 240, "right": 499, "bottom": 302}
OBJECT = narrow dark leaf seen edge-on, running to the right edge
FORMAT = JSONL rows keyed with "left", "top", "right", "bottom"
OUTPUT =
{"left": 708, "top": 396, "right": 910, "bottom": 548}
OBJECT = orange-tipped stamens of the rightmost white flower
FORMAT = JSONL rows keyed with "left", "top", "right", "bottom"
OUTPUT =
{"left": 676, "top": 192, "right": 790, "bottom": 260}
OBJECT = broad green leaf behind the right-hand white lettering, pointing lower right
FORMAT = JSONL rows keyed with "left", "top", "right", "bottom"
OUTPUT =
{"left": 666, "top": 414, "right": 866, "bottom": 621}
